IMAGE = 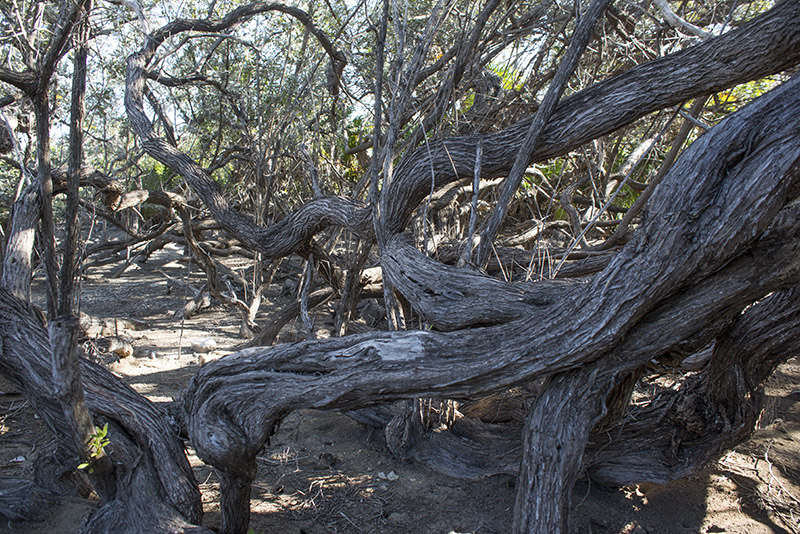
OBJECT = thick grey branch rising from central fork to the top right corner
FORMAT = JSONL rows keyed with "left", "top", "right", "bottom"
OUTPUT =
{"left": 384, "top": 2, "right": 800, "bottom": 233}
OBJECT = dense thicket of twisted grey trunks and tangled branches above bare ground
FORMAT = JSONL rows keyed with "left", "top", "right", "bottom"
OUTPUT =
{"left": 0, "top": 0, "right": 800, "bottom": 533}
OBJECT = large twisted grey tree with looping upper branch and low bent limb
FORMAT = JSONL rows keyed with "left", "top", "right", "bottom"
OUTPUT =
{"left": 114, "top": 1, "right": 800, "bottom": 533}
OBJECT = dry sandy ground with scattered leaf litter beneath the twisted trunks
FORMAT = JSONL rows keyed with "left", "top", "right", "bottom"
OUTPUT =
{"left": 0, "top": 244, "right": 800, "bottom": 534}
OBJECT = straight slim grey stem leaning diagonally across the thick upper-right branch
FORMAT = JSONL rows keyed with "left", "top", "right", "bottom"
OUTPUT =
{"left": 475, "top": 0, "right": 611, "bottom": 266}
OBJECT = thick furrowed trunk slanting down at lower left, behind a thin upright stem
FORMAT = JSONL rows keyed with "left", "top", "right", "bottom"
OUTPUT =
{"left": 0, "top": 288, "right": 208, "bottom": 534}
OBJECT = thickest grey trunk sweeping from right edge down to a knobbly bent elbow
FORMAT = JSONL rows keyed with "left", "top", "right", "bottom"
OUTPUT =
{"left": 178, "top": 76, "right": 800, "bottom": 532}
